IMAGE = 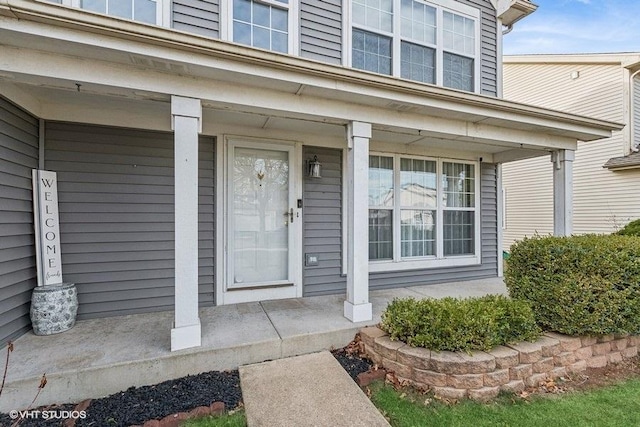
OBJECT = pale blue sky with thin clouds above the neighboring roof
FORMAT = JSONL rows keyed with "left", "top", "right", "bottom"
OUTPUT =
{"left": 503, "top": 0, "right": 640, "bottom": 55}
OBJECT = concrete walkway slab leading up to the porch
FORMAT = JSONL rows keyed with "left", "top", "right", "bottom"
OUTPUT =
{"left": 240, "top": 351, "right": 389, "bottom": 427}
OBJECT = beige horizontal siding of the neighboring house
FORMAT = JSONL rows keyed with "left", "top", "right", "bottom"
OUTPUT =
{"left": 503, "top": 59, "right": 640, "bottom": 250}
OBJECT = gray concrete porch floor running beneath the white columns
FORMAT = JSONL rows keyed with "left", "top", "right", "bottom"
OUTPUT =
{"left": 0, "top": 278, "right": 506, "bottom": 412}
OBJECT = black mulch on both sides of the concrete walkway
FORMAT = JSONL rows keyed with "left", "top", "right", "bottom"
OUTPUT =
{"left": 0, "top": 346, "right": 372, "bottom": 427}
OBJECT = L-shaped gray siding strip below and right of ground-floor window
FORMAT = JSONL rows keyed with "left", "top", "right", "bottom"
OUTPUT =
{"left": 369, "top": 163, "right": 498, "bottom": 290}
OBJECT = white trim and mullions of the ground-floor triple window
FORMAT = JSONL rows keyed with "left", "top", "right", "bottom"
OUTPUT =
{"left": 367, "top": 151, "right": 482, "bottom": 273}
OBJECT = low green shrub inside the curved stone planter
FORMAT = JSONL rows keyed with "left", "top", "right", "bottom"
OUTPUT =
{"left": 381, "top": 295, "right": 540, "bottom": 351}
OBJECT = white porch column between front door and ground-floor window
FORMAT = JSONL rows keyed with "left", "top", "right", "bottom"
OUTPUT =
{"left": 344, "top": 122, "right": 373, "bottom": 322}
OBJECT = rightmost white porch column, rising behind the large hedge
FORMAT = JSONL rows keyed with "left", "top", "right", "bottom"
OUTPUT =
{"left": 551, "top": 150, "right": 575, "bottom": 236}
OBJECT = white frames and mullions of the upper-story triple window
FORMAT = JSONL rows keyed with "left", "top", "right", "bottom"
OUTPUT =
{"left": 342, "top": 0, "right": 482, "bottom": 93}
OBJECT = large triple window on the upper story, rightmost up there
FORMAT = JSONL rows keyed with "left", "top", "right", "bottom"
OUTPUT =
{"left": 351, "top": 0, "right": 480, "bottom": 92}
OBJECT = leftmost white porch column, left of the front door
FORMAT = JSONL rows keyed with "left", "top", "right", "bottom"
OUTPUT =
{"left": 171, "top": 96, "right": 202, "bottom": 351}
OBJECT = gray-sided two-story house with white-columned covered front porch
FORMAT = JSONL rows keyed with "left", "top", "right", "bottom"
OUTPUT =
{"left": 0, "top": 0, "right": 617, "bottom": 349}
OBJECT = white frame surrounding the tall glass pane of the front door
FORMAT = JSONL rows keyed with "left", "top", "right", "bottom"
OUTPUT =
{"left": 215, "top": 135, "right": 302, "bottom": 305}
